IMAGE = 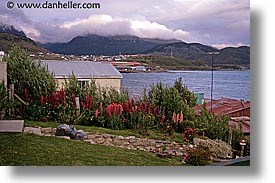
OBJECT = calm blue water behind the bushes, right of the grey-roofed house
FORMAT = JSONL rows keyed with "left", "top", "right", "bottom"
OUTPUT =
{"left": 121, "top": 70, "right": 250, "bottom": 100}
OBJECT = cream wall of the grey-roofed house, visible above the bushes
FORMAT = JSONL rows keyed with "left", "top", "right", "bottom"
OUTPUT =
{"left": 56, "top": 78, "right": 121, "bottom": 92}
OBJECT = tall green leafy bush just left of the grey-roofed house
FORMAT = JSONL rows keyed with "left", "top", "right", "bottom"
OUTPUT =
{"left": 7, "top": 46, "right": 56, "bottom": 101}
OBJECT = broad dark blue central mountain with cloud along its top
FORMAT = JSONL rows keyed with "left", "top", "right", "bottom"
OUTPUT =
{"left": 40, "top": 34, "right": 177, "bottom": 55}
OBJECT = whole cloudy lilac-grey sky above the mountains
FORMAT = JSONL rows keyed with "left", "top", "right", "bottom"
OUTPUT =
{"left": 0, "top": 0, "right": 250, "bottom": 48}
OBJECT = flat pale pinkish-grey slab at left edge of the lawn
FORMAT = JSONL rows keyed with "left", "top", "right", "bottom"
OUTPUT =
{"left": 0, "top": 120, "right": 24, "bottom": 132}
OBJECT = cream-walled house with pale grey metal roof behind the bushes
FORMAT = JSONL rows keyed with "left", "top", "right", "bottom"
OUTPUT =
{"left": 36, "top": 60, "right": 122, "bottom": 91}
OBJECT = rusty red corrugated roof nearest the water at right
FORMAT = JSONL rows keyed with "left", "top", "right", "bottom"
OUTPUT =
{"left": 194, "top": 98, "right": 250, "bottom": 115}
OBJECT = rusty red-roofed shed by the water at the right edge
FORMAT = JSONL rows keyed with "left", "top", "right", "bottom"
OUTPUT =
{"left": 194, "top": 98, "right": 250, "bottom": 117}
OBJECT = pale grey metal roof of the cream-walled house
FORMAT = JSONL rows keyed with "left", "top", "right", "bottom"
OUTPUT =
{"left": 36, "top": 60, "right": 122, "bottom": 79}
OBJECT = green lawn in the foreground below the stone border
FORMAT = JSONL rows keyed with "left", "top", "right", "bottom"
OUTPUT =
{"left": 0, "top": 133, "right": 185, "bottom": 166}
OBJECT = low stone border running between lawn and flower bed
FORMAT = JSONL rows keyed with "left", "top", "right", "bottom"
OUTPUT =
{"left": 24, "top": 127, "right": 190, "bottom": 156}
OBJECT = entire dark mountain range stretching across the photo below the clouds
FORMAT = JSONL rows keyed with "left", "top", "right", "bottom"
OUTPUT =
{"left": 0, "top": 23, "right": 250, "bottom": 65}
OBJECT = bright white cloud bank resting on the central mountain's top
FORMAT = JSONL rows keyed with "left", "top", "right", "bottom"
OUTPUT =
{"left": 28, "top": 14, "right": 195, "bottom": 42}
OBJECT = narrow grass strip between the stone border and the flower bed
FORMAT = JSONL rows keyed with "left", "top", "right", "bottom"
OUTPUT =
{"left": 25, "top": 121, "right": 188, "bottom": 143}
